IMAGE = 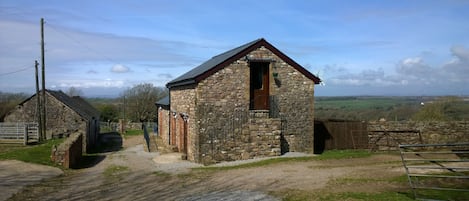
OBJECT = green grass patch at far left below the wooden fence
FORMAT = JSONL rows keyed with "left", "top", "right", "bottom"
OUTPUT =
{"left": 0, "top": 139, "right": 64, "bottom": 166}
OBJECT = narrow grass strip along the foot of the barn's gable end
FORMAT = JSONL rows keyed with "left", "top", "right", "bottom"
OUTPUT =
{"left": 193, "top": 150, "right": 372, "bottom": 171}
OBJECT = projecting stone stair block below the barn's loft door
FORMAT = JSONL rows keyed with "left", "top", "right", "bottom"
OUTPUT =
{"left": 199, "top": 106, "right": 281, "bottom": 164}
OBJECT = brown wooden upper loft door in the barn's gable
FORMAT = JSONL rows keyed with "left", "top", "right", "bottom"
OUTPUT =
{"left": 249, "top": 62, "right": 270, "bottom": 110}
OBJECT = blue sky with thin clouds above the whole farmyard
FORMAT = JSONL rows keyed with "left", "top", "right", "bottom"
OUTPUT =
{"left": 0, "top": 0, "right": 469, "bottom": 97}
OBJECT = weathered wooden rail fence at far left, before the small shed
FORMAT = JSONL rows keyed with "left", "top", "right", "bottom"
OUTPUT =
{"left": 0, "top": 123, "right": 39, "bottom": 145}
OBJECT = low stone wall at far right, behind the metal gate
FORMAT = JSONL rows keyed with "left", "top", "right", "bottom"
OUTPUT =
{"left": 368, "top": 121, "right": 469, "bottom": 150}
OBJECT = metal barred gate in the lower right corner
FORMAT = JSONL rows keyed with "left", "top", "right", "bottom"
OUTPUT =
{"left": 399, "top": 143, "right": 469, "bottom": 200}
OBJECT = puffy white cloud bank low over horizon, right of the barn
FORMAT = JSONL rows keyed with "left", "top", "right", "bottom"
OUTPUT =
{"left": 323, "top": 46, "right": 469, "bottom": 94}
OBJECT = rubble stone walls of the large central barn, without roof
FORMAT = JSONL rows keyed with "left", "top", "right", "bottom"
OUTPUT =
{"left": 160, "top": 47, "right": 314, "bottom": 163}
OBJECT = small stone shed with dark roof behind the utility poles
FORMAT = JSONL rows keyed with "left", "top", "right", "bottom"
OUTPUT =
{"left": 4, "top": 90, "right": 100, "bottom": 152}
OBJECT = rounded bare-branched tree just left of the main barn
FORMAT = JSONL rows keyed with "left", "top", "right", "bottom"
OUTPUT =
{"left": 121, "top": 83, "right": 168, "bottom": 121}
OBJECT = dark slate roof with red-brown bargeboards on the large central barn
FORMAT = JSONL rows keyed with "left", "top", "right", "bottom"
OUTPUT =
{"left": 166, "top": 38, "right": 321, "bottom": 88}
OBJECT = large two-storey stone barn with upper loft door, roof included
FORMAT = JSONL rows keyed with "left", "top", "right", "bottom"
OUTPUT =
{"left": 156, "top": 38, "right": 320, "bottom": 164}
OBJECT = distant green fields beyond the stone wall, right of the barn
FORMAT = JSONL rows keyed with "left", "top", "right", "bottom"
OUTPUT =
{"left": 314, "top": 96, "right": 469, "bottom": 121}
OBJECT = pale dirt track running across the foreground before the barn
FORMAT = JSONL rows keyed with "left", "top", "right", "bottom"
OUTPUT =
{"left": 3, "top": 133, "right": 404, "bottom": 200}
